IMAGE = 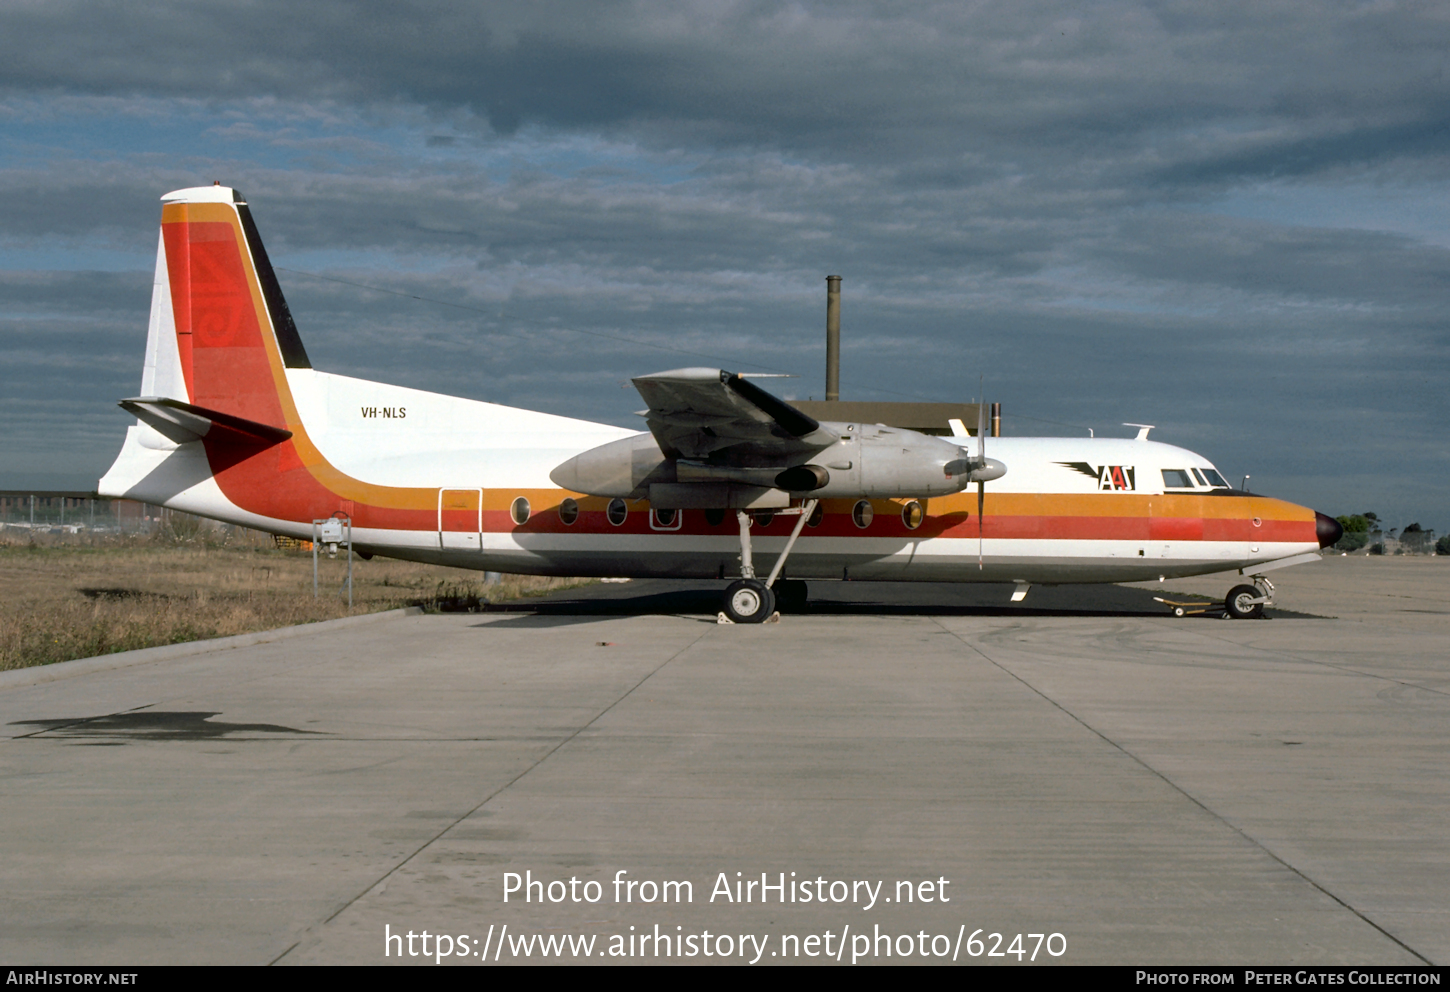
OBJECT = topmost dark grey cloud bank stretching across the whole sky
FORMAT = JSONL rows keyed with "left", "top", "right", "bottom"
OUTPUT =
{"left": 8, "top": 0, "right": 1450, "bottom": 181}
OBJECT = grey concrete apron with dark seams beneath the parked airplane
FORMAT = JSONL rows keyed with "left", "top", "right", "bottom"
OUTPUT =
{"left": 0, "top": 557, "right": 1450, "bottom": 967}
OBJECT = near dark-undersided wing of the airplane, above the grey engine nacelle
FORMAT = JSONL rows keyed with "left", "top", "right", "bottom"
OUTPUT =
{"left": 631, "top": 368, "right": 835, "bottom": 458}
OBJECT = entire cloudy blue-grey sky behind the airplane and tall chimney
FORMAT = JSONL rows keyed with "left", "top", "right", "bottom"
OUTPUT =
{"left": 0, "top": 0, "right": 1450, "bottom": 531}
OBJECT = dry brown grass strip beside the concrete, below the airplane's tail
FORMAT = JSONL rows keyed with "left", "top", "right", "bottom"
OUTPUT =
{"left": 0, "top": 528, "right": 583, "bottom": 670}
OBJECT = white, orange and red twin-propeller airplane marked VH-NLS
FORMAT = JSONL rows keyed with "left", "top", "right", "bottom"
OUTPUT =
{"left": 99, "top": 186, "right": 1340, "bottom": 622}
